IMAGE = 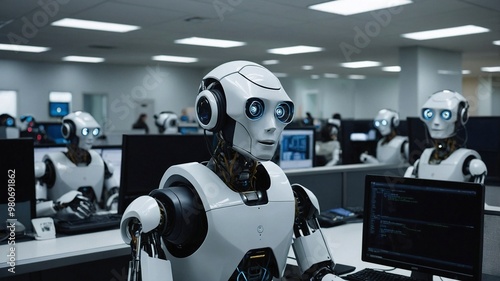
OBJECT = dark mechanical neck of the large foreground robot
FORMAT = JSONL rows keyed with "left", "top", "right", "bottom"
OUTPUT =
{"left": 212, "top": 138, "right": 258, "bottom": 192}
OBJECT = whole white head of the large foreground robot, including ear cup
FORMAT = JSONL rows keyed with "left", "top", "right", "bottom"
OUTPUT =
{"left": 195, "top": 61, "right": 294, "bottom": 161}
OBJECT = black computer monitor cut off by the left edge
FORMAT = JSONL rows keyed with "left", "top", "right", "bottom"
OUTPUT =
{"left": 0, "top": 138, "right": 36, "bottom": 234}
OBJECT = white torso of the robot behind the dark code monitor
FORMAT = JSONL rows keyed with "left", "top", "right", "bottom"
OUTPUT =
{"left": 417, "top": 148, "right": 481, "bottom": 181}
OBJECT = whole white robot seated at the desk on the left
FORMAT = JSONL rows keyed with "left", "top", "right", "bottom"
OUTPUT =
{"left": 35, "top": 111, "right": 118, "bottom": 219}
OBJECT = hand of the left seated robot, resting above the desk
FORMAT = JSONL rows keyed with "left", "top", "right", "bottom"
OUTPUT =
{"left": 54, "top": 190, "right": 95, "bottom": 219}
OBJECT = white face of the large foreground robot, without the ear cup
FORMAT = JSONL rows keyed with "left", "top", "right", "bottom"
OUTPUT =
{"left": 212, "top": 62, "right": 294, "bottom": 161}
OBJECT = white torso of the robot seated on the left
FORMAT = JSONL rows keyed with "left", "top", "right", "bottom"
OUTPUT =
{"left": 43, "top": 150, "right": 104, "bottom": 200}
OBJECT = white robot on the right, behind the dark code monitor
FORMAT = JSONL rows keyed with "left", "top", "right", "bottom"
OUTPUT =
{"left": 405, "top": 90, "right": 487, "bottom": 183}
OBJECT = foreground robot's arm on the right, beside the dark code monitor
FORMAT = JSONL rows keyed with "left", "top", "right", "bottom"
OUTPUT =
{"left": 292, "top": 184, "right": 335, "bottom": 281}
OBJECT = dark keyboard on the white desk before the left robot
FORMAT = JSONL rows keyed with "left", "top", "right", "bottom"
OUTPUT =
{"left": 55, "top": 214, "right": 122, "bottom": 234}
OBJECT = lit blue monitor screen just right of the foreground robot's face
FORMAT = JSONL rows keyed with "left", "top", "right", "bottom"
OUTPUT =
{"left": 278, "top": 127, "right": 315, "bottom": 170}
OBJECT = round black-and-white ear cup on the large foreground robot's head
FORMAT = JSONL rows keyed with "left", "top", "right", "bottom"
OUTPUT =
{"left": 195, "top": 89, "right": 226, "bottom": 132}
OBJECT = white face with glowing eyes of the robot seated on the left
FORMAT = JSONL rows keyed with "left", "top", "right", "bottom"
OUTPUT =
{"left": 63, "top": 111, "right": 101, "bottom": 150}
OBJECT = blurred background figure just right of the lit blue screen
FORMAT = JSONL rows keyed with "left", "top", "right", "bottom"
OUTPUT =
{"left": 315, "top": 118, "right": 341, "bottom": 166}
